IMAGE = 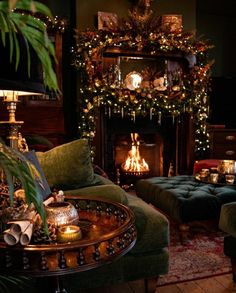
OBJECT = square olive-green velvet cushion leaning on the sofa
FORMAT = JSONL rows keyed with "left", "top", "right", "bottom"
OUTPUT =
{"left": 36, "top": 139, "right": 94, "bottom": 190}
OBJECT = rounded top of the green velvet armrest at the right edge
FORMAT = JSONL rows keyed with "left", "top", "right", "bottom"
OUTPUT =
{"left": 219, "top": 202, "right": 236, "bottom": 238}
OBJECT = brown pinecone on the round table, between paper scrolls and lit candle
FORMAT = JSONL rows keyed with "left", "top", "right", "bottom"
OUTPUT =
{"left": 32, "top": 224, "right": 57, "bottom": 243}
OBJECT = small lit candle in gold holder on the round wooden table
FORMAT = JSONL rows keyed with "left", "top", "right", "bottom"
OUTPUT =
{"left": 57, "top": 225, "right": 82, "bottom": 242}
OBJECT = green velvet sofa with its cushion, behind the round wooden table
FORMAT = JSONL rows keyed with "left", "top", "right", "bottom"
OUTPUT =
{"left": 24, "top": 139, "right": 169, "bottom": 293}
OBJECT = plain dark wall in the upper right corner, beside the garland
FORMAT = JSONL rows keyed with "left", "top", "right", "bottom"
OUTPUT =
{"left": 196, "top": 0, "right": 236, "bottom": 77}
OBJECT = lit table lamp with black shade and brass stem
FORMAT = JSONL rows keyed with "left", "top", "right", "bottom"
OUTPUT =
{"left": 0, "top": 38, "right": 45, "bottom": 148}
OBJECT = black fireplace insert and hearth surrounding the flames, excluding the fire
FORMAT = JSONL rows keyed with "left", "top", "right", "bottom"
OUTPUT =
{"left": 95, "top": 114, "right": 179, "bottom": 183}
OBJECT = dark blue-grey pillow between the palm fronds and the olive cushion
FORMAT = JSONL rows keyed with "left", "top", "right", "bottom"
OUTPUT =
{"left": 24, "top": 151, "right": 51, "bottom": 200}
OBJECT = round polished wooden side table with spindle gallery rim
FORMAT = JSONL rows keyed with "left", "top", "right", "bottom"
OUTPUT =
{"left": 0, "top": 196, "right": 137, "bottom": 293}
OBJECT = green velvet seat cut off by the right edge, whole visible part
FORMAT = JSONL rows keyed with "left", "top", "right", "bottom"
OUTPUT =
{"left": 219, "top": 202, "right": 236, "bottom": 283}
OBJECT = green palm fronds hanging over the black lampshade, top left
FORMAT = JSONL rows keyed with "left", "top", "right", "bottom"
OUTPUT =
{"left": 0, "top": 0, "right": 59, "bottom": 91}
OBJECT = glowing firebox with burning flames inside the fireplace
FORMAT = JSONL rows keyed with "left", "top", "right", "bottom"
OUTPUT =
{"left": 114, "top": 132, "right": 163, "bottom": 185}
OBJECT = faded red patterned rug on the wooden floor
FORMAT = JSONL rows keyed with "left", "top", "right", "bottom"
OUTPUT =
{"left": 157, "top": 219, "right": 231, "bottom": 286}
